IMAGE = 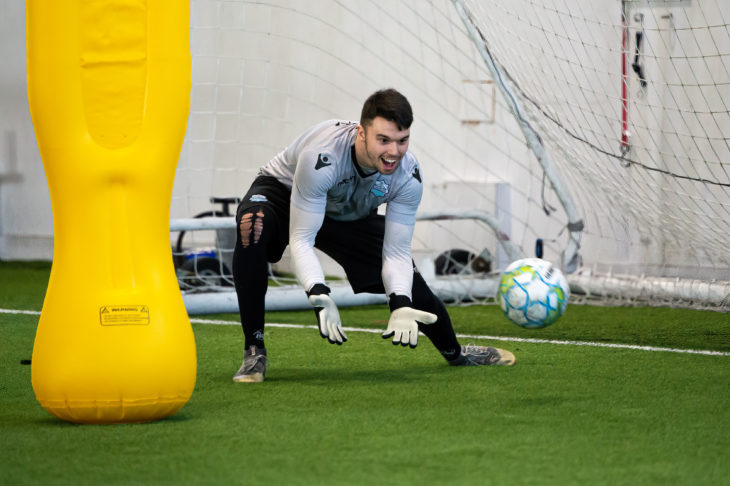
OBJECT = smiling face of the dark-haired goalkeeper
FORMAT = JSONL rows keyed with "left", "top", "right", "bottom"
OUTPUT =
{"left": 357, "top": 116, "right": 411, "bottom": 175}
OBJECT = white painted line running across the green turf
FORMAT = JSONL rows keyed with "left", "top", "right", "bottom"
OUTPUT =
{"left": 0, "top": 309, "right": 730, "bottom": 356}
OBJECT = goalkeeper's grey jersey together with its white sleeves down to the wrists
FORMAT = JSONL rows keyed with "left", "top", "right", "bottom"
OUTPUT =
{"left": 261, "top": 120, "right": 423, "bottom": 297}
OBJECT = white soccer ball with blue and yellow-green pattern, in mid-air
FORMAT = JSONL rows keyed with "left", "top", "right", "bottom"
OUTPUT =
{"left": 498, "top": 258, "right": 570, "bottom": 329}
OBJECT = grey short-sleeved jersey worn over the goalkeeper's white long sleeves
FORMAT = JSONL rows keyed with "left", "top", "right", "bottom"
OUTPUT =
{"left": 261, "top": 120, "right": 423, "bottom": 225}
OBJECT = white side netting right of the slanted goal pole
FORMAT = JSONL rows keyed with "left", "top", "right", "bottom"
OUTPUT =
{"left": 452, "top": 0, "right": 730, "bottom": 307}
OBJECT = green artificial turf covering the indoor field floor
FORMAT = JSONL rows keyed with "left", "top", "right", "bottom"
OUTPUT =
{"left": 0, "top": 263, "right": 730, "bottom": 485}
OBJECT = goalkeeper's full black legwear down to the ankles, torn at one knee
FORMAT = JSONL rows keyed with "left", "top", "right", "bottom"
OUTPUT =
{"left": 233, "top": 176, "right": 460, "bottom": 360}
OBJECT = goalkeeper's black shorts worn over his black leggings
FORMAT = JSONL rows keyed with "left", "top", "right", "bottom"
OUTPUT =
{"left": 236, "top": 176, "right": 385, "bottom": 294}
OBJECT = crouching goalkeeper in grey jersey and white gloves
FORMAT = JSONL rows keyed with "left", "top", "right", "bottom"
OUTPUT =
{"left": 233, "top": 89, "right": 515, "bottom": 382}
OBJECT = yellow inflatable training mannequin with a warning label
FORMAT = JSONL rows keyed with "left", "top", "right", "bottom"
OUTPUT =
{"left": 26, "top": 0, "right": 196, "bottom": 423}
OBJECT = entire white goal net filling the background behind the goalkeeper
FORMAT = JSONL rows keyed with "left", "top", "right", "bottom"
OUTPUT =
{"left": 171, "top": 0, "right": 730, "bottom": 313}
